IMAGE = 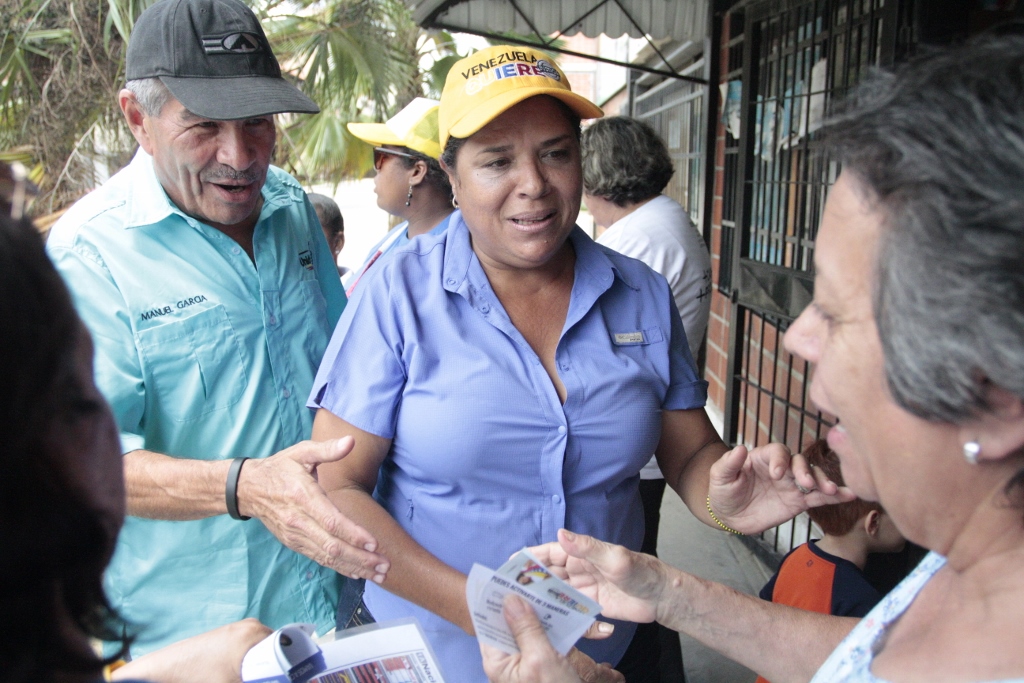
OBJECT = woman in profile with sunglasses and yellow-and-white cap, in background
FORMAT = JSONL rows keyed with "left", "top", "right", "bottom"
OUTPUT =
{"left": 345, "top": 97, "right": 453, "bottom": 296}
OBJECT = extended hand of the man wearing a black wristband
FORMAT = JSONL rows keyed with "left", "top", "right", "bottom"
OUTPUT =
{"left": 239, "top": 436, "right": 389, "bottom": 583}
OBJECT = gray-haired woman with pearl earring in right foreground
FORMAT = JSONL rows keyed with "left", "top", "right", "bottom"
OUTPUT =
{"left": 484, "top": 25, "right": 1024, "bottom": 683}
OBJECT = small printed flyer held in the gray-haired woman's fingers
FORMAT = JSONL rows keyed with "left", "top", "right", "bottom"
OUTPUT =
{"left": 466, "top": 550, "right": 601, "bottom": 654}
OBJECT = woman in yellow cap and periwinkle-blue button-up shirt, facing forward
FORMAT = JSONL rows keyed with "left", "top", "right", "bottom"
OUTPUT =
{"left": 309, "top": 46, "right": 840, "bottom": 683}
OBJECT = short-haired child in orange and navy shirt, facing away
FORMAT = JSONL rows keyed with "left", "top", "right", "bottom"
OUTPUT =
{"left": 758, "top": 438, "right": 905, "bottom": 683}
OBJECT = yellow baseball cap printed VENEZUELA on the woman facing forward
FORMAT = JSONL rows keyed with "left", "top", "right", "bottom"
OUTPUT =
{"left": 438, "top": 45, "right": 604, "bottom": 150}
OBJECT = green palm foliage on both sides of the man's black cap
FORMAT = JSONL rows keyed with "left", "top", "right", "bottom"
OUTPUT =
{"left": 0, "top": 0, "right": 468, "bottom": 214}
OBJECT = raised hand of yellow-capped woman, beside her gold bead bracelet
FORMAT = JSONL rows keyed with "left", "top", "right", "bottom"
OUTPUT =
{"left": 708, "top": 443, "right": 856, "bottom": 533}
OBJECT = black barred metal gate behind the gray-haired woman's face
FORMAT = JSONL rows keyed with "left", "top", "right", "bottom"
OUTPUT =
{"left": 719, "top": 0, "right": 900, "bottom": 552}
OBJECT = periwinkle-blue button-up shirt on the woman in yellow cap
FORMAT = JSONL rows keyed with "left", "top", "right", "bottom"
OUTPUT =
{"left": 310, "top": 212, "right": 707, "bottom": 683}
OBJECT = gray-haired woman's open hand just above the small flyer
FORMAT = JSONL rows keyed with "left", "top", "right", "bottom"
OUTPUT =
{"left": 530, "top": 529, "right": 667, "bottom": 624}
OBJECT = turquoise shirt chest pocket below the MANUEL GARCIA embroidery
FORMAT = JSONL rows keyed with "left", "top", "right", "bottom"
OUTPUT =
{"left": 136, "top": 305, "right": 248, "bottom": 422}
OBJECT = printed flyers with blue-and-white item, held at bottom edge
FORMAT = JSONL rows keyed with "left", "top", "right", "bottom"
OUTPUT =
{"left": 242, "top": 618, "right": 444, "bottom": 683}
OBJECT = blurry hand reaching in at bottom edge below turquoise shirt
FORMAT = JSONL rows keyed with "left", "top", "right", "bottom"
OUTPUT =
{"left": 111, "top": 618, "right": 271, "bottom": 683}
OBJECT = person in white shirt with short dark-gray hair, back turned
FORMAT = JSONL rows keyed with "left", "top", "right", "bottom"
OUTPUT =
{"left": 582, "top": 116, "right": 711, "bottom": 680}
